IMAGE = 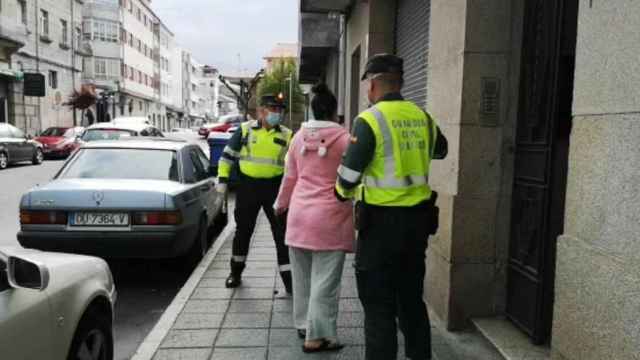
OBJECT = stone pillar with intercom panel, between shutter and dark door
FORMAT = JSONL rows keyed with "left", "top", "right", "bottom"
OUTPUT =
{"left": 425, "top": 0, "right": 523, "bottom": 329}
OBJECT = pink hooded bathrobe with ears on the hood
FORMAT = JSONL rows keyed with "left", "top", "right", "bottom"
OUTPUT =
{"left": 275, "top": 120, "right": 355, "bottom": 252}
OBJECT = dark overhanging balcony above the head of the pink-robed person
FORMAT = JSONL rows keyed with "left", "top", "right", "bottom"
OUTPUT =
{"left": 299, "top": 13, "right": 340, "bottom": 83}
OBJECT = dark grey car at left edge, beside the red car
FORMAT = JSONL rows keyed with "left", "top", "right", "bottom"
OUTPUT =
{"left": 0, "top": 123, "right": 44, "bottom": 170}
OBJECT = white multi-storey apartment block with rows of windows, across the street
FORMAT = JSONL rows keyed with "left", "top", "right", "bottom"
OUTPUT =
{"left": 83, "top": 0, "right": 182, "bottom": 130}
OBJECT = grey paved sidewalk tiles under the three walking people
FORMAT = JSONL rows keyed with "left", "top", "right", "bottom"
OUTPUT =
{"left": 148, "top": 215, "right": 499, "bottom": 360}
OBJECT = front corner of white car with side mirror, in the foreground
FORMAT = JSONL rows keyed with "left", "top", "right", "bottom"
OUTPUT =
{"left": 0, "top": 248, "right": 116, "bottom": 360}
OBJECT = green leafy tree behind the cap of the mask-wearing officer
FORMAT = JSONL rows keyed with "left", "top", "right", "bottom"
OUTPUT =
{"left": 258, "top": 59, "right": 305, "bottom": 113}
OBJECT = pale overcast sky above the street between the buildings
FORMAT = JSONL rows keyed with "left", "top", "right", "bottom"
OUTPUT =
{"left": 151, "top": 0, "right": 299, "bottom": 72}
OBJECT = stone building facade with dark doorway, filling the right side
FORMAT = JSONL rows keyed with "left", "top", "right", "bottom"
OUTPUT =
{"left": 301, "top": 0, "right": 640, "bottom": 360}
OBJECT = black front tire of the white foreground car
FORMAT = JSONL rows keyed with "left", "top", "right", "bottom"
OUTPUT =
{"left": 67, "top": 311, "right": 113, "bottom": 360}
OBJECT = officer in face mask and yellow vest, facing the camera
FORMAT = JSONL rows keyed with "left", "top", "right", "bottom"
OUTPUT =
{"left": 217, "top": 95, "right": 292, "bottom": 294}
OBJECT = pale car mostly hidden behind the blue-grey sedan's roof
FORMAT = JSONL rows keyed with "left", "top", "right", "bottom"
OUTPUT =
{"left": 80, "top": 121, "right": 164, "bottom": 143}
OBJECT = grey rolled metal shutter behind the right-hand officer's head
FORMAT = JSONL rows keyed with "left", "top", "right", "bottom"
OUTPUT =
{"left": 396, "top": 0, "right": 431, "bottom": 108}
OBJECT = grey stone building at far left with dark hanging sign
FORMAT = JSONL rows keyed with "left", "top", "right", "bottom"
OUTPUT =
{"left": 0, "top": 0, "right": 85, "bottom": 134}
